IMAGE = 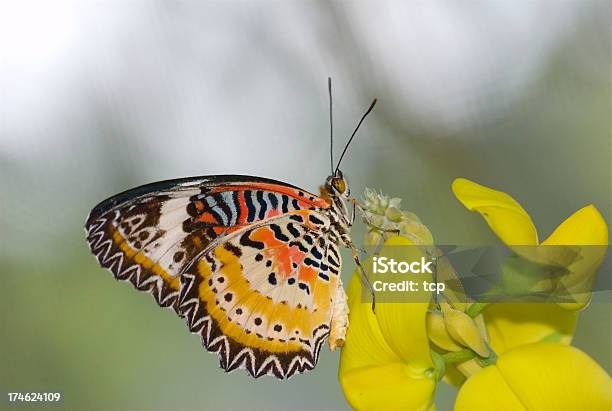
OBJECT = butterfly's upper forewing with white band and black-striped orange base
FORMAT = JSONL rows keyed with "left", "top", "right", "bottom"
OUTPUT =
{"left": 85, "top": 175, "right": 327, "bottom": 315}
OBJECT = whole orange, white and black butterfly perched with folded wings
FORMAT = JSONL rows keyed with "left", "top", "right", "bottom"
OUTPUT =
{"left": 85, "top": 82, "right": 376, "bottom": 379}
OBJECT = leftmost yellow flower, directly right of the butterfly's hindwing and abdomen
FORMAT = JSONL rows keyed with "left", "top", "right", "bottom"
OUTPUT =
{"left": 339, "top": 236, "right": 439, "bottom": 410}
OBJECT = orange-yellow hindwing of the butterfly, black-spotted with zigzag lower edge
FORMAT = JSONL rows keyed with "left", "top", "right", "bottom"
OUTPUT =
{"left": 179, "top": 210, "right": 344, "bottom": 378}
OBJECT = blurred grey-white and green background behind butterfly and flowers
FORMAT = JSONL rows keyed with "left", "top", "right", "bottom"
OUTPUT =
{"left": 0, "top": 0, "right": 612, "bottom": 410}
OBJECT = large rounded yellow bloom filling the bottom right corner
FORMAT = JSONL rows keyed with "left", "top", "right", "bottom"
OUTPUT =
{"left": 455, "top": 343, "right": 612, "bottom": 411}
